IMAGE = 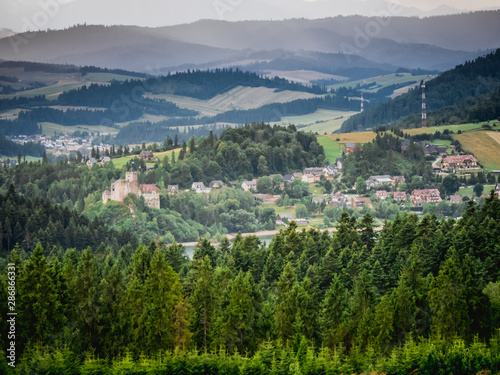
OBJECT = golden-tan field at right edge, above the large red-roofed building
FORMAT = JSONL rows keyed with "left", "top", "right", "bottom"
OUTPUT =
{"left": 454, "top": 131, "right": 500, "bottom": 170}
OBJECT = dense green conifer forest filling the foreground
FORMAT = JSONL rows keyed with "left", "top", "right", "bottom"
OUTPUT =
{"left": 0, "top": 194, "right": 500, "bottom": 374}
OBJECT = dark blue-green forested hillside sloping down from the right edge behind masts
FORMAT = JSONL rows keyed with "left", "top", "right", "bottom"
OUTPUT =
{"left": 340, "top": 49, "right": 500, "bottom": 132}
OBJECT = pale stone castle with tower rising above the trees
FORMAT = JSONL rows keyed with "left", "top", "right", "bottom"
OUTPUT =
{"left": 102, "top": 172, "right": 161, "bottom": 208}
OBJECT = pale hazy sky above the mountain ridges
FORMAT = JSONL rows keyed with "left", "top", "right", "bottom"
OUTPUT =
{"left": 0, "top": 0, "right": 500, "bottom": 31}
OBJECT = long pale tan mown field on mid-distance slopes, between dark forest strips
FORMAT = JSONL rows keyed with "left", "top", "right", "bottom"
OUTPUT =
{"left": 146, "top": 86, "right": 318, "bottom": 116}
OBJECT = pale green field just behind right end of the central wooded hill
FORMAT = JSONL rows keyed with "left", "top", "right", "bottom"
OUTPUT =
{"left": 275, "top": 109, "right": 358, "bottom": 134}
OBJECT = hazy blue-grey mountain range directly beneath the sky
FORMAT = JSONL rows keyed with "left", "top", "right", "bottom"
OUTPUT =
{"left": 0, "top": 11, "right": 500, "bottom": 77}
